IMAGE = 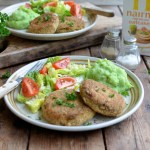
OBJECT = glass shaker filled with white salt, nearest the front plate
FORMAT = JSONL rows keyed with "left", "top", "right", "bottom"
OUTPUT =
{"left": 116, "top": 36, "right": 141, "bottom": 71}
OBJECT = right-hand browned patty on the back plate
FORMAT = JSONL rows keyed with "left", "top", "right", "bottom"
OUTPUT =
{"left": 56, "top": 16, "right": 85, "bottom": 33}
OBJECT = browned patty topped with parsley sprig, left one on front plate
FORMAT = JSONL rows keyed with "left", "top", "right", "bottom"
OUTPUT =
{"left": 42, "top": 90, "right": 95, "bottom": 126}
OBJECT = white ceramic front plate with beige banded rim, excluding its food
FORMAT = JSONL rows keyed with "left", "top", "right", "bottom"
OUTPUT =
{"left": 5, "top": 56, "right": 144, "bottom": 131}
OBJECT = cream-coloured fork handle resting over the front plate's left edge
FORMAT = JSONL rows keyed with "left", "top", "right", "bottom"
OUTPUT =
{"left": 0, "top": 80, "right": 18, "bottom": 99}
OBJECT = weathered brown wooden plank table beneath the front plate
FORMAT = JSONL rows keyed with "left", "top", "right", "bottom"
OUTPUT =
{"left": 0, "top": 0, "right": 150, "bottom": 150}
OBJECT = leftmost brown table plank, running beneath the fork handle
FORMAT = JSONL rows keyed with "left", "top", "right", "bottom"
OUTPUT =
{"left": 0, "top": 66, "right": 30, "bottom": 150}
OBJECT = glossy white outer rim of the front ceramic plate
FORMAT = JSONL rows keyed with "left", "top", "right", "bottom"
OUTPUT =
{"left": 4, "top": 55, "right": 144, "bottom": 132}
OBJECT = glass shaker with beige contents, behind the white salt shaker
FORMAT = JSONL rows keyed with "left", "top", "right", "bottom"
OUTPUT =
{"left": 100, "top": 29, "right": 120, "bottom": 60}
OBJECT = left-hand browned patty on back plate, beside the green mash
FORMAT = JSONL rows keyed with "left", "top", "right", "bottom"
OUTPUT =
{"left": 28, "top": 13, "right": 59, "bottom": 34}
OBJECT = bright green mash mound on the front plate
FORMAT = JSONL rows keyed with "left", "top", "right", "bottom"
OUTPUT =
{"left": 86, "top": 59, "right": 132, "bottom": 93}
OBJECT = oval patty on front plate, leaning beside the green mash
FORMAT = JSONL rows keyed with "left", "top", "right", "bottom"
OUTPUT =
{"left": 80, "top": 79, "right": 126, "bottom": 116}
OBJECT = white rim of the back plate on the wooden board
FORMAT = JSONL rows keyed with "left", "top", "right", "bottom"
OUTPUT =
{"left": 1, "top": 1, "right": 97, "bottom": 41}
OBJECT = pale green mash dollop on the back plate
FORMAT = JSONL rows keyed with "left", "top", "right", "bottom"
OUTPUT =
{"left": 7, "top": 6, "right": 39, "bottom": 29}
